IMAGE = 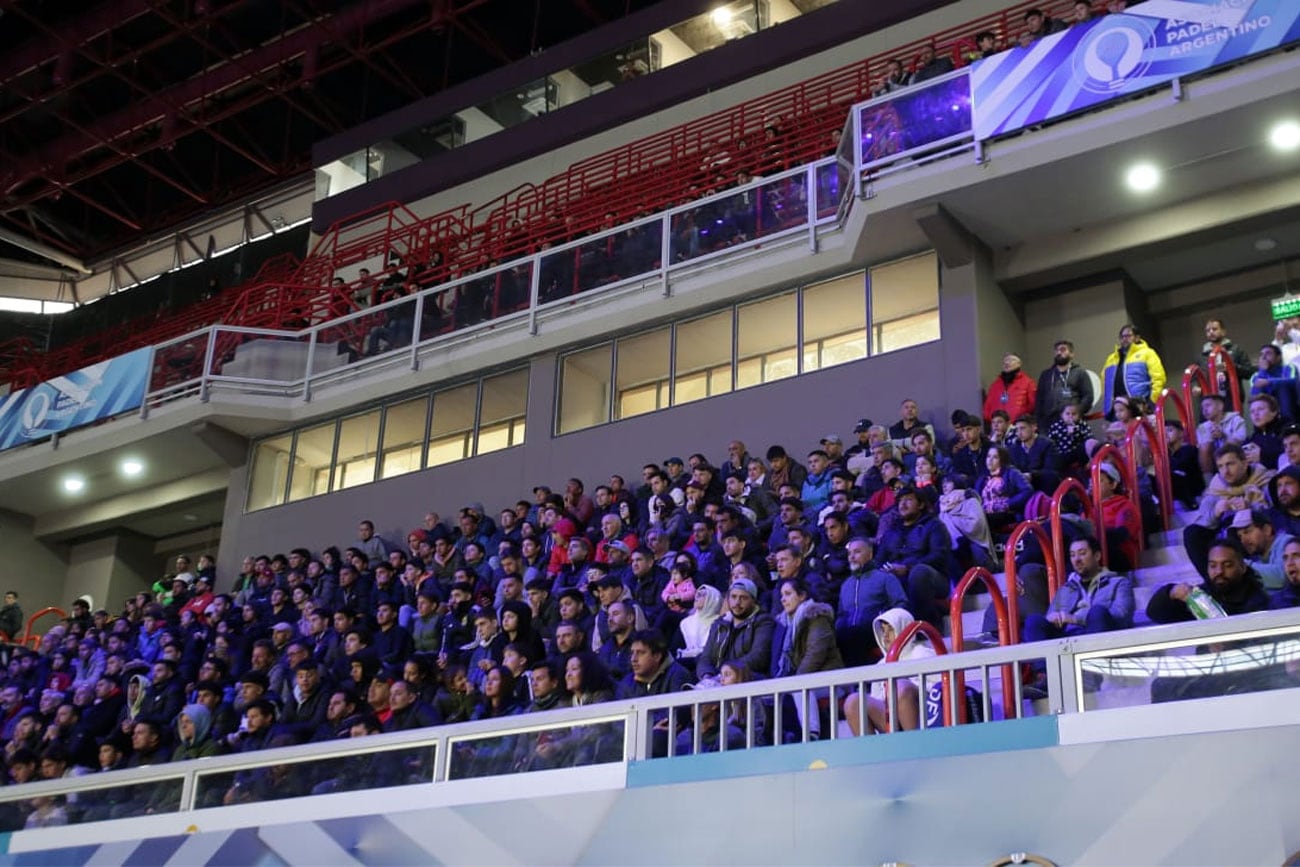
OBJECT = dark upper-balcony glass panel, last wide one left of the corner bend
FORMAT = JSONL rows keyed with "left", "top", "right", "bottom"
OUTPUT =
{"left": 670, "top": 170, "right": 809, "bottom": 263}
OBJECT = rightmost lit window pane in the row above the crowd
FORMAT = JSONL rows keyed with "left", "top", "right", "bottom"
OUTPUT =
{"left": 871, "top": 252, "right": 939, "bottom": 352}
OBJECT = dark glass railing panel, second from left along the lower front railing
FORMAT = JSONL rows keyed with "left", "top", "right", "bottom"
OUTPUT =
{"left": 194, "top": 736, "right": 436, "bottom": 810}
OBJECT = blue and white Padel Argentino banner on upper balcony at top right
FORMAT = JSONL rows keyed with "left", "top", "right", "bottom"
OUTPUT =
{"left": 971, "top": 0, "right": 1300, "bottom": 140}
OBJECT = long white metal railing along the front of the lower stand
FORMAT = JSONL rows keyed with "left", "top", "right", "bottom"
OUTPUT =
{"left": 0, "top": 610, "right": 1300, "bottom": 812}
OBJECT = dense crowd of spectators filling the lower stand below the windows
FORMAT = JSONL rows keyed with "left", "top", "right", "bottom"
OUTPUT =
{"left": 0, "top": 310, "right": 1300, "bottom": 828}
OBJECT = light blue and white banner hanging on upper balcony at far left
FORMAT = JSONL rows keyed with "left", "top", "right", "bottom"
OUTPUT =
{"left": 0, "top": 348, "right": 152, "bottom": 450}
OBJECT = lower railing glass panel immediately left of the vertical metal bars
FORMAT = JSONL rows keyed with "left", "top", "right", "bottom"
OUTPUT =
{"left": 447, "top": 716, "right": 627, "bottom": 780}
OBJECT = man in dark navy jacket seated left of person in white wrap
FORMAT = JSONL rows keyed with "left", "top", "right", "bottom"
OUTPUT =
{"left": 876, "top": 487, "right": 953, "bottom": 629}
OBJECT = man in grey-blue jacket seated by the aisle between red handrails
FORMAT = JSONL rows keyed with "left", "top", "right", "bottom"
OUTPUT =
{"left": 1023, "top": 537, "right": 1135, "bottom": 641}
